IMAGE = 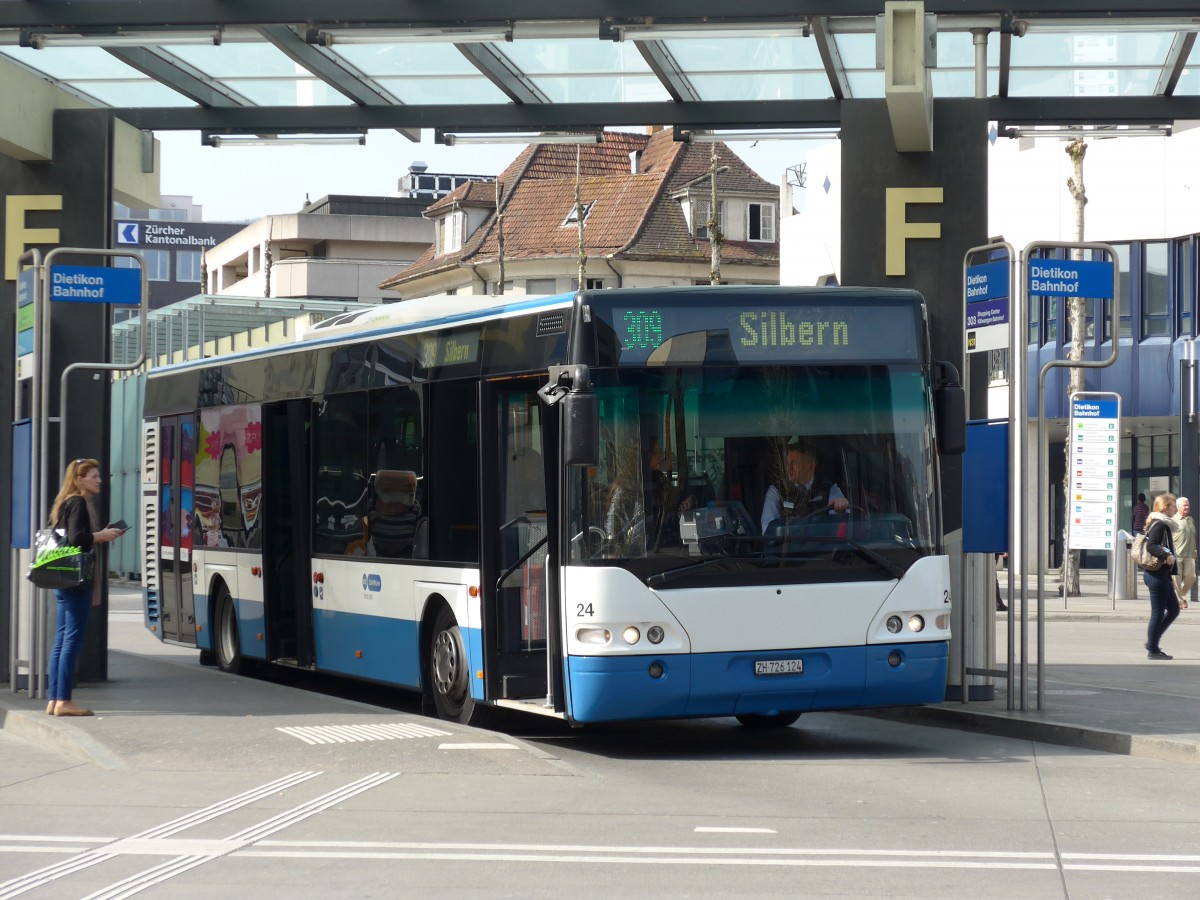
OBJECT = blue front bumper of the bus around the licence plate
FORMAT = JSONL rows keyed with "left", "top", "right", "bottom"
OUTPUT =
{"left": 566, "top": 643, "right": 948, "bottom": 722}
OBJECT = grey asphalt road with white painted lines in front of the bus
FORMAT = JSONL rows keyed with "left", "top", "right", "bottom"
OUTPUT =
{"left": 0, "top": 592, "right": 1200, "bottom": 900}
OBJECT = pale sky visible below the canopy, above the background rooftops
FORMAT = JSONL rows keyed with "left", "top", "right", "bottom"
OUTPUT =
{"left": 155, "top": 131, "right": 824, "bottom": 222}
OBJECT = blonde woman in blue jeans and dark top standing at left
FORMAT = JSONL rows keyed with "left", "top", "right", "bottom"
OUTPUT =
{"left": 46, "top": 460, "right": 121, "bottom": 715}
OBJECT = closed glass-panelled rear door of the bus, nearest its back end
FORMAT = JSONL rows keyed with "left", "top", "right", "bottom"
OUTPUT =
{"left": 158, "top": 414, "right": 196, "bottom": 647}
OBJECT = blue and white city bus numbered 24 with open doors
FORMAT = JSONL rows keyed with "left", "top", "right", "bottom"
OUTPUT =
{"left": 142, "top": 286, "right": 965, "bottom": 727}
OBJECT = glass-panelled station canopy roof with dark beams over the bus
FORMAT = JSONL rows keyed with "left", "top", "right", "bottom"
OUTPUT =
{"left": 0, "top": 0, "right": 1200, "bottom": 144}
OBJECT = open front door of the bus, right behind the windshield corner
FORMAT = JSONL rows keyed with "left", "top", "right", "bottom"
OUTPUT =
{"left": 481, "top": 378, "right": 556, "bottom": 701}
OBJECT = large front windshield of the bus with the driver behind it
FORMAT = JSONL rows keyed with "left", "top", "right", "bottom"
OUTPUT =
{"left": 568, "top": 364, "right": 940, "bottom": 587}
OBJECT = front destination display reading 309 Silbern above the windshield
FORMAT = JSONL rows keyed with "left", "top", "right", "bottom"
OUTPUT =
{"left": 612, "top": 304, "right": 920, "bottom": 366}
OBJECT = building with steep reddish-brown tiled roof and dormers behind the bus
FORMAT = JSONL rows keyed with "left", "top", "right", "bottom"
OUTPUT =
{"left": 380, "top": 130, "right": 779, "bottom": 299}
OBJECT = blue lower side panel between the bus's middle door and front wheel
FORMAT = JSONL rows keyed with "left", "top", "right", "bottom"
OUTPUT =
{"left": 313, "top": 610, "right": 424, "bottom": 688}
